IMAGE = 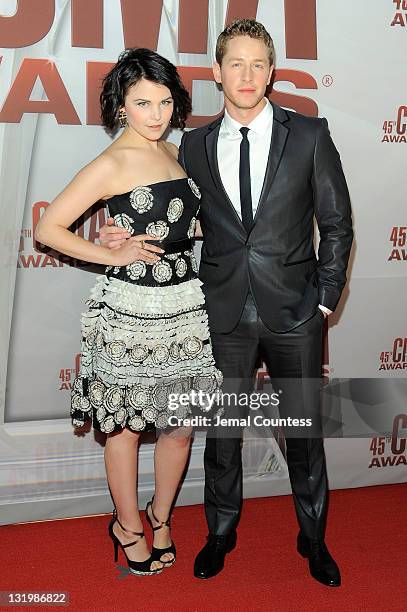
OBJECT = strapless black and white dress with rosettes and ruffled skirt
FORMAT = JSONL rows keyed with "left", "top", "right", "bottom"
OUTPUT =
{"left": 71, "top": 178, "right": 222, "bottom": 433}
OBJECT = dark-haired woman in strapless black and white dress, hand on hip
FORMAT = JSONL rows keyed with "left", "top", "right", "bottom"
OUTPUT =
{"left": 36, "top": 49, "right": 221, "bottom": 575}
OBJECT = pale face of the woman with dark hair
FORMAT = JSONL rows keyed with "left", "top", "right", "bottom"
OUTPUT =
{"left": 120, "top": 79, "right": 174, "bottom": 140}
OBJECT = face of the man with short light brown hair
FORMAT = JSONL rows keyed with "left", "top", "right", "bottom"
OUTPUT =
{"left": 213, "top": 36, "right": 274, "bottom": 109}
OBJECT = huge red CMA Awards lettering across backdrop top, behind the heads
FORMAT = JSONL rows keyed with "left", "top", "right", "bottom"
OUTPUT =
{"left": 0, "top": 0, "right": 318, "bottom": 128}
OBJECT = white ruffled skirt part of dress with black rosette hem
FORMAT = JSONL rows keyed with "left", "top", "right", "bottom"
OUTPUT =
{"left": 71, "top": 276, "right": 222, "bottom": 433}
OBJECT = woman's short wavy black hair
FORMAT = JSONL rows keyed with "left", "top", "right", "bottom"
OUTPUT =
{"left": 100, "top": 48, "right": 192, "bottom": 132}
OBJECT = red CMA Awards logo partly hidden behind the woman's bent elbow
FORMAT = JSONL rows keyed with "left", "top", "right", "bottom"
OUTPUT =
{"left": 17, "top": 202, "right": 106, "bottom": 268}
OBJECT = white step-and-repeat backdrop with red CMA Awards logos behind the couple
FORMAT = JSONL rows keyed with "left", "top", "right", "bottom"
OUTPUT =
{"left": 0, "top": 0, "right": 407, "bottom": 522}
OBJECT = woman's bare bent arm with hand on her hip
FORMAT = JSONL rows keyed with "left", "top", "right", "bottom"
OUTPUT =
{"left": 35, "top": 155, "right": 161, "bottom": 266}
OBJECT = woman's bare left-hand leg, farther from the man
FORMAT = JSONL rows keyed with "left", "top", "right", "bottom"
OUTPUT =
{"left": 105, "top": 428, "right": 162, "bottom": 569}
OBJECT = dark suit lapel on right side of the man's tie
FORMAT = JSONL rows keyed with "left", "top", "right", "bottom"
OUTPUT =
{"left": 252, "top": 103, "right": 290, "bottom": 229}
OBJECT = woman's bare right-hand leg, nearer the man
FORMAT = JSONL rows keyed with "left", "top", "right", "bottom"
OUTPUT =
{"left": 149, "top": 427, "right": 192, "bottom": 561}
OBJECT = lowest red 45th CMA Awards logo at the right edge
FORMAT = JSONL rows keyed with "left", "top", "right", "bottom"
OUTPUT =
{"left": 369, "top": 414, "right": 407, "bottom": 468}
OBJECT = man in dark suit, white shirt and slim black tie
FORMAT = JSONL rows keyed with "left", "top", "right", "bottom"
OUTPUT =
{"left": 101, "top": 20, "right": 353, "bottom": 586}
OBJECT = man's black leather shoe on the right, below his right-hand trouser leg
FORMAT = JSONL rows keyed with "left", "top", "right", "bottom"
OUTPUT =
{"left": 297, "top": 531, "right": 341, "bottom": 586}
